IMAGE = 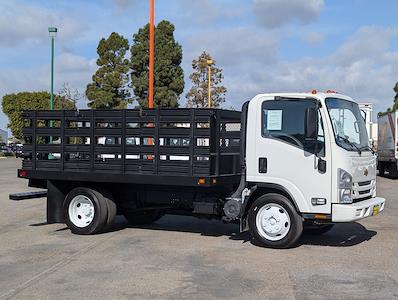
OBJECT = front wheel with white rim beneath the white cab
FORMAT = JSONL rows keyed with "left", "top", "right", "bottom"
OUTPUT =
{"left": 248, "top": 194, "right": 303, "bottom": 249}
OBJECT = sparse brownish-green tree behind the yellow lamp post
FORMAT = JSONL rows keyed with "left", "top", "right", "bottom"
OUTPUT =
{"left": 186, "top": 51, "right": 227, "bottom": 107}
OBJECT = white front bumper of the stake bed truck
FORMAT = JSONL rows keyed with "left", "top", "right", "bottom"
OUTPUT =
{"left": 332, "top": 197, "right": 386, "bottom": 222}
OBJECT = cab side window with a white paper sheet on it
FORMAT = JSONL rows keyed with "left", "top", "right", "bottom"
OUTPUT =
{"left": 262, "top": 99, "right": 325, "bottom": 156}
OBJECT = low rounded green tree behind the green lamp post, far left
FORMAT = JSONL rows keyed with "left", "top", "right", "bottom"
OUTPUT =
{"left": 2, "top": 92, "right": 75, "bottom": 139}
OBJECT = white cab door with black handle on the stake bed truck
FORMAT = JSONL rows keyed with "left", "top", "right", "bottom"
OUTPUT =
{"left": 255, "top": 98, "right": 332, "bottom": 213}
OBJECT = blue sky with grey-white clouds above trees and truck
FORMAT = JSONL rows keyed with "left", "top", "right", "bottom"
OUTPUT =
{"left": 0, "top": 0, "right": 398, "bottom": 134}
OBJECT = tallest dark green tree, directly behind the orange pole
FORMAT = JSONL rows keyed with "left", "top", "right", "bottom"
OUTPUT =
{"left": 130, "top": 21, "right": 184, "bottom": 108}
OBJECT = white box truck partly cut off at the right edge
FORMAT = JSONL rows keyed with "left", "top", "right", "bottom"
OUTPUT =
{"left": 377, "top": 112, "right": 398, "bottom": 177}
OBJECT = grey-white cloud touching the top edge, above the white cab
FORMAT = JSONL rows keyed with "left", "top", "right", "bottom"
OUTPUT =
{"left": 253, "top": 0, "right": 324, "bottom": 28}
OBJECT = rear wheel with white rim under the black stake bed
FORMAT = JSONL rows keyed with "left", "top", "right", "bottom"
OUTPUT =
{"left": 63, "top": 187, "right": 108, "bottom": 235}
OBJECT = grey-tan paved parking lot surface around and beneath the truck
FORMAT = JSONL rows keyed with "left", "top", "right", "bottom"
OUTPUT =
{"left": 0, "top": 158, "right": 398, "bottom": 299}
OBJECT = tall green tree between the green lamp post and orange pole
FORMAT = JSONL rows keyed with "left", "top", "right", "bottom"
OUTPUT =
{"left": 86, "top": 32, "right": 131, "bottom": 109}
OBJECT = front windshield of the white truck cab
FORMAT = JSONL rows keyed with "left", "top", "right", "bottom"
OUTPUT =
{"left": 326, "top": 98, "right": 370, "bottom": 152}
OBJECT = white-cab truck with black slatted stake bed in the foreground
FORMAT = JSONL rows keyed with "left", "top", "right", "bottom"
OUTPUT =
{"left": 18, "top": 93, "right": 385, "bottom": 248}
